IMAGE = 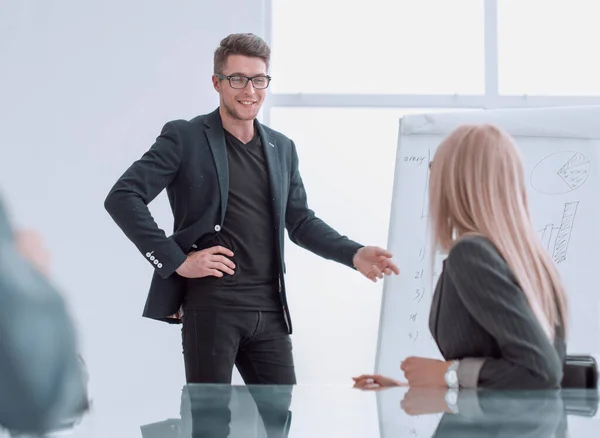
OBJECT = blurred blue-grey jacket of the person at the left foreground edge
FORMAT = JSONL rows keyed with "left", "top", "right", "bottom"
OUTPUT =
{"left": 0, "top": 202, "right": 87, "bottom": 432}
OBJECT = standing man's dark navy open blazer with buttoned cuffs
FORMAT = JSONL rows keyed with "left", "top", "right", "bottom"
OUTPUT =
{"left": 104, "top": 108, "right": 362, "bottom": 333}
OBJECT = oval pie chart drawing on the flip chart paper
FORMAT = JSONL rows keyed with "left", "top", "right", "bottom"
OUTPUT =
{"left": 531, "top": 151, "right": 590, "bottom": 195}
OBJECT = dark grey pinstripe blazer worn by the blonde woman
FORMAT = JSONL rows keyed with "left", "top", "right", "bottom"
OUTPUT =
{"left": 429, "top": 236, "right": 566, "bottom": 389}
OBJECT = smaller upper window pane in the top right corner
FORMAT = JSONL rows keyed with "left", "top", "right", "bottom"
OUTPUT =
{"left": 498, "top": 0, "right": 600, "bottom": 96}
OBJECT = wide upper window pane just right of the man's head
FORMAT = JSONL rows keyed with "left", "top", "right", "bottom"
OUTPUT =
{"left": 271, "top": 0, "right": 484, "bottom": 94}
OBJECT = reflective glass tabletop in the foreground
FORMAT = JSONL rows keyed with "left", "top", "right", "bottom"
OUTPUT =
{"left": 0, "top": 385, "right": 600, "bottom": 438}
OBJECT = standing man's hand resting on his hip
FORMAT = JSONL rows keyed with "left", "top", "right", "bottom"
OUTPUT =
{"left": 177, "top": 246, "right": 235, "bottom": 278}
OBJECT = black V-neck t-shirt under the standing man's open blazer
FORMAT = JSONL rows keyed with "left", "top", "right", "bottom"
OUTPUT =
{"left": 185, "top": 131, "right": 281, "bottom": 310}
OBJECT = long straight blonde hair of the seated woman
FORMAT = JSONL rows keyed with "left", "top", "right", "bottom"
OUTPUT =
{"left": 429, "top": 124, "right": 567, "bottom": 339}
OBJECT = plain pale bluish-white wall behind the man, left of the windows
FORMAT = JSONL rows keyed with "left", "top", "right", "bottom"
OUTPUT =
{"left": 0, "top": 0, "right": 264, "bottom": 436}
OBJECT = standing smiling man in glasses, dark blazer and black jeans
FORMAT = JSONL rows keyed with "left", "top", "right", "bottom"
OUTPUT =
{"left": 105, "top": 34, "right": 398, "bottom": 385}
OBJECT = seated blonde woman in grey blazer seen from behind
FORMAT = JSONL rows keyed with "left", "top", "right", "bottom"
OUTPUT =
{"left": 354, "top": 125, "right": 567, "bottom": 389}
